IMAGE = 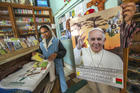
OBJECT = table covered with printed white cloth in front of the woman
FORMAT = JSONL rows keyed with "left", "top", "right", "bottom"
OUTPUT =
{"left": 0, "top": 62, "right": 55, "bottom": 93}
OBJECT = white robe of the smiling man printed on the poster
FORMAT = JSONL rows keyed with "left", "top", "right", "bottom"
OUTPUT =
{"left": 74, "top": 47, "right": 123, "bottom": 69}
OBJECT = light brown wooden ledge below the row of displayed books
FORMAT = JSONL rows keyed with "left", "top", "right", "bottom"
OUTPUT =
{"left": 0, "top": 46, "right": 39, "bottom": 65}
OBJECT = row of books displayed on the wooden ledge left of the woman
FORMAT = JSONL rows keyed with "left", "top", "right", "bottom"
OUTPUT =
{"left": 0, "top": 36, "right": 38, "bottom": 55}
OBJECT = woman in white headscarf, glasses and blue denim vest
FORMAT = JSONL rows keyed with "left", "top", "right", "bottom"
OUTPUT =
{"left": 39, "top": 25, "right": 67, "bottom": 93}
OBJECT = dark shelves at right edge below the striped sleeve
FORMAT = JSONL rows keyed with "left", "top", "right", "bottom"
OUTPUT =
{"left": 127, "top": 29, "right": 140, "bottom": 93}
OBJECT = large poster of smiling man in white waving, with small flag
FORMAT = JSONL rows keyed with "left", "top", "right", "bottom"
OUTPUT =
{"left": 70, "top": 7, "right": 123, "bottom": 89}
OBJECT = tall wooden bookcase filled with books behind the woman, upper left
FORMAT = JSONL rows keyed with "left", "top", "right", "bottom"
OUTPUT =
{"left": 0, "top": 2, "right": 53, "bottom": 38}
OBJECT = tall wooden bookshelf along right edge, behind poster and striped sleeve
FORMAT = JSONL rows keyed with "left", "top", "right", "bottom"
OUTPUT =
{"left": 121, "top": 0, "right": 140, "bottom": 93}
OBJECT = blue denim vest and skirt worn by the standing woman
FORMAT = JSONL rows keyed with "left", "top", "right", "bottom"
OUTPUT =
{"left": 40, "top": 38, "right": 68, "bottom": 92}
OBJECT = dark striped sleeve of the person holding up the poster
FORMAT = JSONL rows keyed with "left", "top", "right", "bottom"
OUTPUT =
{"left": 120, "top": 22, "right": 140, "bottom": 48}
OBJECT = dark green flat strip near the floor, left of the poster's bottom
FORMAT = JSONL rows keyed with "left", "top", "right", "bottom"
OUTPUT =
{"left": 66, "top": 80, "right": 87, "bottom": 93}
